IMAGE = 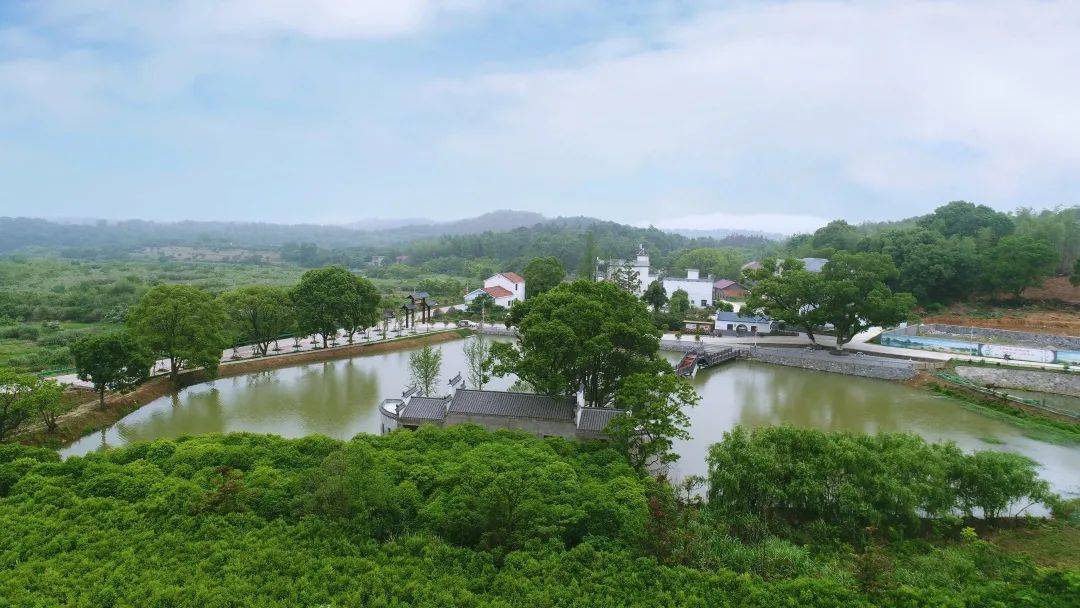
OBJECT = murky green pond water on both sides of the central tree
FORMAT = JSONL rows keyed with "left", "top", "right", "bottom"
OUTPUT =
{"left": 62, "top": 341, "right": 1080, "bottom": 496}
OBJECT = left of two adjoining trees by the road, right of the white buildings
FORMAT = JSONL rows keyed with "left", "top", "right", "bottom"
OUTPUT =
{"left": 743, "top": 258, "right": 824, "bottom": 343}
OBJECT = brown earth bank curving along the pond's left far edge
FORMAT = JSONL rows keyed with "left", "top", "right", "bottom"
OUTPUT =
{"left": 16, "top": 328, "right": 472, "bottom": 447}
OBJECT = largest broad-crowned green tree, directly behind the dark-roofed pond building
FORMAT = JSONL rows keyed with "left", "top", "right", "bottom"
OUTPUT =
{"left": 491, "top": 281, "right": 671, "bottom": 406}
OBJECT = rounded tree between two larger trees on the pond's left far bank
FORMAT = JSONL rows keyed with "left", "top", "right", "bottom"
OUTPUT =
{"left": 218, "top": 285, "right": 296, "bottom": 355}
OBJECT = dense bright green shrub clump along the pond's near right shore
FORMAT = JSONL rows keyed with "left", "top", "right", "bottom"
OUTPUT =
{"left": 708, "top": 427, "right": 1052, "bottom": 540}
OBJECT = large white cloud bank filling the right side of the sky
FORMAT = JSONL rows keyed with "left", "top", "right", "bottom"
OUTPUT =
{"left": 438, "top": 0, "right": 1080, "bottom": 215}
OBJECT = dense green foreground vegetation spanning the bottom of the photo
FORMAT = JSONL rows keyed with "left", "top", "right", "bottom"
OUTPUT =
{"left": 0, "top": 425, "right": 1067, "bottom": 608}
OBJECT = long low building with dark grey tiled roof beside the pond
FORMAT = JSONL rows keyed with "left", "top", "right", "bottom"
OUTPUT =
{"left": 379, "top": 388, "right": 625, "bottom": 440}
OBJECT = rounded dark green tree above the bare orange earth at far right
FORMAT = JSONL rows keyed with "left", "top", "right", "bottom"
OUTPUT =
{"left": 983, "top": 234, "right": 1056, "bottom": 298}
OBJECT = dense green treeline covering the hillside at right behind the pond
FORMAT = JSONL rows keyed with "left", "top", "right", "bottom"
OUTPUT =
{"left": 784, "top": 201, "right": 1080, "bottom": 308}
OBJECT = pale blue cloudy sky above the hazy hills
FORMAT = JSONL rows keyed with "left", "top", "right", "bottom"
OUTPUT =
{"left": 0, "top": 0, "right": 1080, "bottom": 232}
